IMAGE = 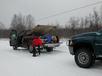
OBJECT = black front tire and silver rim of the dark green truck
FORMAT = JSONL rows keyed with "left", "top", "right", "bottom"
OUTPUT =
{"left": 75, "top": 48, "right": 95, "bottom": 68}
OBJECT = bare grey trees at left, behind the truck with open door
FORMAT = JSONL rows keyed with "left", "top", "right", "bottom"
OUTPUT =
{"left": 0, "top": 14, "right": 35, "bottom": 38}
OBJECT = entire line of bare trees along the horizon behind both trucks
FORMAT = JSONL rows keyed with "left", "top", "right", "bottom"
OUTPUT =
{"left": 0, "top": 7, "right": 102, "bottom": 38}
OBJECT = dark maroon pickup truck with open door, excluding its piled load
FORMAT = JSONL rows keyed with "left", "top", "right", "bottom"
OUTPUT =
{"left": 9, "top": 30, "right": 60, "bottom": 53}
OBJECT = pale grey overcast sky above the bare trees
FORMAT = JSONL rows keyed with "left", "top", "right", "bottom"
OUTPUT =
{"left": 0, "top": 0, "right": 102, "bottom": 26}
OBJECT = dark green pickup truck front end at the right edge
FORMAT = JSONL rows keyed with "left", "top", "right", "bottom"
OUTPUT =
{"left": 68, "top": 30, "right": 102, "bottom": 68}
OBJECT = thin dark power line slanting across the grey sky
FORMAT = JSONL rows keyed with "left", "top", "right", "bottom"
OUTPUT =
{"left": 36, "top": 1, "right": 102, "bottom": 21}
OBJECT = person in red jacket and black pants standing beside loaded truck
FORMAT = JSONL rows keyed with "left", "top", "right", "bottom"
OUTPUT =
{"left": 32, "top": 36, "right": 43, "bottom": 56}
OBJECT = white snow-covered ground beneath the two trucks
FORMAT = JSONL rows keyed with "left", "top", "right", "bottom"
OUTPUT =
{"left": 0, "top": 39, "right": 102, "bottom": 76}
